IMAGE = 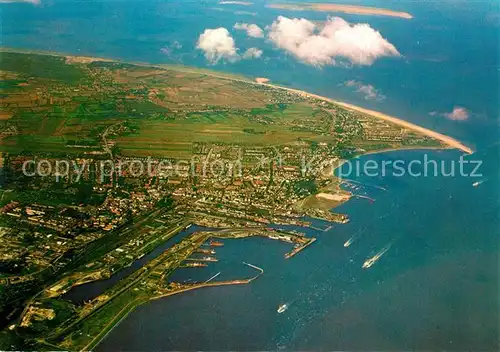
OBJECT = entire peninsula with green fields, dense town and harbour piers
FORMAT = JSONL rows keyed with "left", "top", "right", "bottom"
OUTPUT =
{"left": 0, "top": 52, "right": 444, "bottom": 350}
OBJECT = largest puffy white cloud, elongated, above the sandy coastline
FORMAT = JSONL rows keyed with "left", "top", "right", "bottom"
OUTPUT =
{"left": 268, "top": 16, "right": 401, "bottom": 67}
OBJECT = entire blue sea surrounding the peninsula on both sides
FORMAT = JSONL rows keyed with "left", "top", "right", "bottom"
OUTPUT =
{"left": 0, "top": 0, "right": 500, "bottom": 351}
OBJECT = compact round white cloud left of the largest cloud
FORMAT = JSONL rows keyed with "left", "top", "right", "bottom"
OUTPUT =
{"left": 196, "top": 27, "right": 238, "bottom": 64}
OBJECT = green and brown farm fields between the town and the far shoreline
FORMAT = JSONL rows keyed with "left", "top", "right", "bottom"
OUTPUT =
{"left": 0, "top": 51, "right": 439, "bottom": 158}
